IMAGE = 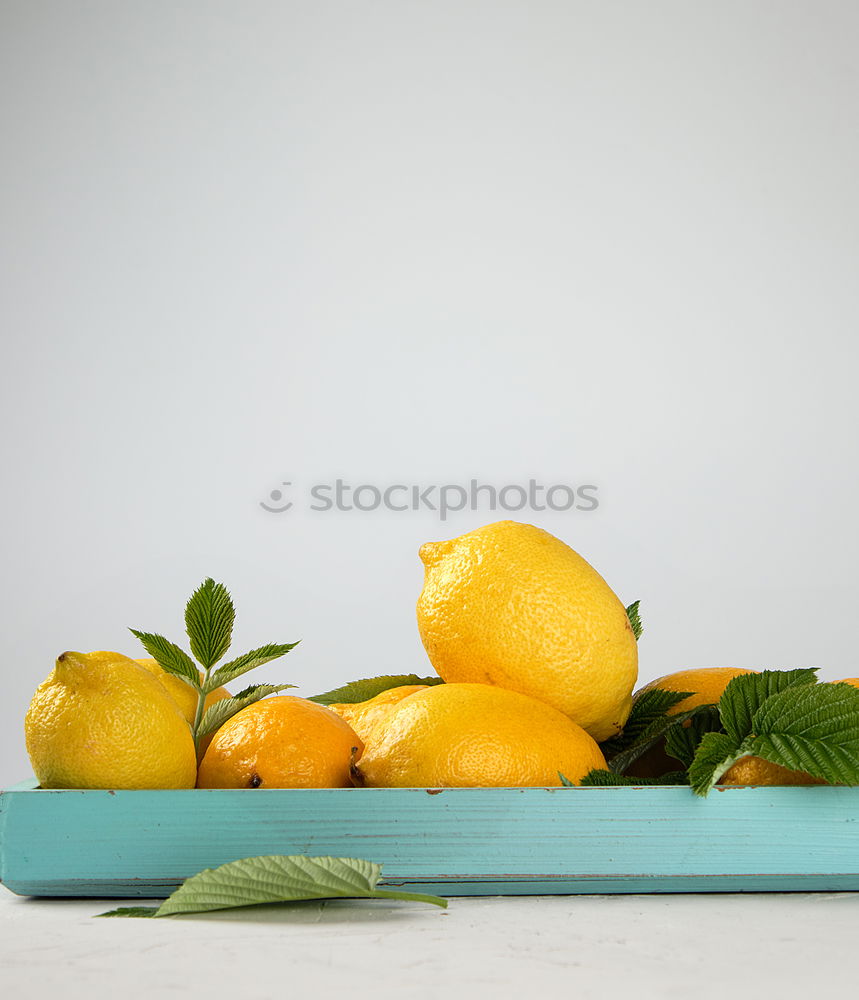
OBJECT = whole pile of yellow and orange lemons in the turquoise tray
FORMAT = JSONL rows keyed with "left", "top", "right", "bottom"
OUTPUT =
{"left": 25, "top": 521, "right": 848, "bottom": 789}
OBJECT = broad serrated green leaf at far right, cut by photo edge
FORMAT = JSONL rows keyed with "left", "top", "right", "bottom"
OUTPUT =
{"left": 751, "top": 684, "right": 859, "bottom": 785}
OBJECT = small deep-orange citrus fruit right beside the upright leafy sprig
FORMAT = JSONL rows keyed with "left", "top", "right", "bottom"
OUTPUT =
{"left": 197, "top": 695, "right": 364, "bottom": 788}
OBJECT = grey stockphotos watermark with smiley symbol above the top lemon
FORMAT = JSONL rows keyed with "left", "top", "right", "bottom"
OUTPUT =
{"left": 260, "top": 479, "right": 599, "bottom": 521}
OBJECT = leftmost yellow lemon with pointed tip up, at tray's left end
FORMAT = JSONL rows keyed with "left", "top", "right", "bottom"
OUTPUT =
{"left": 24, "top": 652, "right": 197, "bottom": 788}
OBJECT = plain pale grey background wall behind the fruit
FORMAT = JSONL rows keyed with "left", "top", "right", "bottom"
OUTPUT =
{"left": 0, "top": 0, "right": 859, "bottom": 783}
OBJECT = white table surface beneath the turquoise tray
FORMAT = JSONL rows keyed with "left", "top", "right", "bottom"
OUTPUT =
{"left": 0, "top": 888, "right": 859, "bottom": 1000}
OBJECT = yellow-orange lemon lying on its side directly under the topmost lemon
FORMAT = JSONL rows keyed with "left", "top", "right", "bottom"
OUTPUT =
{"left": 358, "top": 684, "right": 606, "bottom": 788}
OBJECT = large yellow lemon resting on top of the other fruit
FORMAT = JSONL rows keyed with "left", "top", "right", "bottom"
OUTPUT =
{"left": 417, "top": 521, "right": 638, "bottom": 740}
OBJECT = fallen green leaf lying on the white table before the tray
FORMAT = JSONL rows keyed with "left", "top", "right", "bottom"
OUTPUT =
{"left": 97, "top": 854, "right": 447, "bottom": 917}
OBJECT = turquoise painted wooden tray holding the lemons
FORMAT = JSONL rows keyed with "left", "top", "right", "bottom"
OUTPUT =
{"left": 0, "top": 782, "right": 859, "bottom": 897}
